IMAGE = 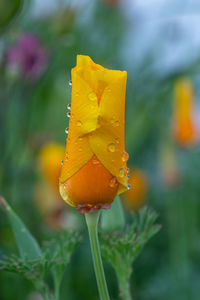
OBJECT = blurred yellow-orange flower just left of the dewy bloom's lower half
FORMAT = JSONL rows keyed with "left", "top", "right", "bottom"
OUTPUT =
{"left": 35, "top": 143, "right": 65, "bottom": 228}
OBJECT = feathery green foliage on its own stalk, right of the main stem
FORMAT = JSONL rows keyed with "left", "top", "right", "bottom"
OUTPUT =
{"left": 100, "top": 207, "right": 160, "bottom": 299}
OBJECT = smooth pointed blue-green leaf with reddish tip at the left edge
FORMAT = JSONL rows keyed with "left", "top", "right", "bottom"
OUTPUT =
{"left": 0, "top": 197, "right": 42, "bottom": 260}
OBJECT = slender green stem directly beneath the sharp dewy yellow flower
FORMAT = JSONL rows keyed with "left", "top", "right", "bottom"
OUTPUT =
{"left": 85, "top": 211, "right": 110, "bottom": 300}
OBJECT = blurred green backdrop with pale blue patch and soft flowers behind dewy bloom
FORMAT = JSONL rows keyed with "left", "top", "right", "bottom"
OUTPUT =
{"left": 0, "top": 0, "right": 200, "bottom": 300}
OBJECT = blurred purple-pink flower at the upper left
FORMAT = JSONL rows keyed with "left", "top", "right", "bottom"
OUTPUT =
{"left": 6, "top": 34, "right": 48, "bottom": 80}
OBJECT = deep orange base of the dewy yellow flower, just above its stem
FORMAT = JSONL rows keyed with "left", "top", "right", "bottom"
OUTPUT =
{"left": 60, "top": 155, "right": 119, "bottom": 213}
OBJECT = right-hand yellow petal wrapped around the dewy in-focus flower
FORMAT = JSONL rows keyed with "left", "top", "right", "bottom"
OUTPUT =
{"left": 90, "top": 71, "right": 127, "bottom": 192}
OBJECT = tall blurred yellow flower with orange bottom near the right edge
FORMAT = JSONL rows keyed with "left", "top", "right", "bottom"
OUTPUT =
{"left": 173, "top": 78, "right": 197, "bottom": 147}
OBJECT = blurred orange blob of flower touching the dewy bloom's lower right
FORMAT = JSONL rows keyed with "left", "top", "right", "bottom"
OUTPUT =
{"left": 123, "top": 169, "right": 148, "bottom": 211}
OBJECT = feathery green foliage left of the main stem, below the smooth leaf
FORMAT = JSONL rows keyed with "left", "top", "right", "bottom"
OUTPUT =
{"left": 0, "top": 232, "right": 81, "bottom": 281}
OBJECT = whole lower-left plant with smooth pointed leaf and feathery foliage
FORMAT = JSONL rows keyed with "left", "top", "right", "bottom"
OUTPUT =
{"left": 0, "top": 197, "right": 80, "bottom": 300}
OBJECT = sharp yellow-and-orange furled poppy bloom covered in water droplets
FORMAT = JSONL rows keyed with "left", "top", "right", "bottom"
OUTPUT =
{"left": 60, "top": 55, "right": 128, "bottom": 212}
